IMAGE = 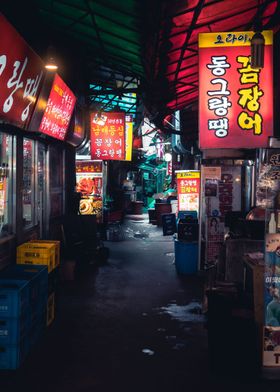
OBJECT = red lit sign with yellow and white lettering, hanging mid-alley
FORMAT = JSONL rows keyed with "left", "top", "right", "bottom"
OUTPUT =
{"left": 90, "top": 112, "right": 125, "bottom": 160}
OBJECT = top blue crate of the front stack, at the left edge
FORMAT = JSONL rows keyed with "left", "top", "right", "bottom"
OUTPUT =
{"left": 0, "top": 279, "right": 30, "bottom": 317}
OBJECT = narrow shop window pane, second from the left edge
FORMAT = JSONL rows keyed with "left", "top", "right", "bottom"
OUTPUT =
{"left": 22, "top": 138, "right": 35, "bottom": 227}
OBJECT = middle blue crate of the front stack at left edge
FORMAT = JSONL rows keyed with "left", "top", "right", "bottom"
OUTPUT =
{"left": 0, "top": 314, "right": 30, "bottom": 345}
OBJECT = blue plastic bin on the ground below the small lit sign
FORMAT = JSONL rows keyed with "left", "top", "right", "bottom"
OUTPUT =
{"left": 174, "top": 239, "right": 198, "bottom": 275}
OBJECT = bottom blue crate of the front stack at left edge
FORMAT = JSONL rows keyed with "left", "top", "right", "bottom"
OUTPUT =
{"left": 0, "top": 336, "right": 30, "bottom": 370}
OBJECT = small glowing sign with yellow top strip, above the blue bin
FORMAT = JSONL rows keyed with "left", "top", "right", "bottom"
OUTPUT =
{"left": 176, "top": 170, "right": 200, "bottom": 213}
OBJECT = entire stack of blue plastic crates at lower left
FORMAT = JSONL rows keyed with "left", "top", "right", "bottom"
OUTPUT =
{"left": 0, "top": 265, "right": 48, "bottom": 369}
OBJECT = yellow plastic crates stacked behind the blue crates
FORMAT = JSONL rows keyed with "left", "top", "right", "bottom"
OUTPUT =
{"left": 17, "top": 240, "right": 60, "bottom": 326}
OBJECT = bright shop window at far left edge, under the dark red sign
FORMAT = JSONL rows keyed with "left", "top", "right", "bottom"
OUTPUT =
{"left": 0, "top": 132, "right": 13, "bottom": 237}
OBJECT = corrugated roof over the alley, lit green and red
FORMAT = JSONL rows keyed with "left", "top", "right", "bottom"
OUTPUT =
{"left": 1, "top": 0, "right": 280, "bottom": 128}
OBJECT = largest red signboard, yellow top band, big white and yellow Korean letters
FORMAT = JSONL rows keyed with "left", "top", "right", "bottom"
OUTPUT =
{"left": 199, "top": 31, "right": 273, "bottom": 149}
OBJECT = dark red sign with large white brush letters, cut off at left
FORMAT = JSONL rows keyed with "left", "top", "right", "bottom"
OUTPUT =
{"left": 0, "top": 14, "right": 44, "bottom": 128}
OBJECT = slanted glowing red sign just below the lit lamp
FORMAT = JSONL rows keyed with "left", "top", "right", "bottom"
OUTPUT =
{"left": 39, "top": 74, "right": 76, "bottom": 140}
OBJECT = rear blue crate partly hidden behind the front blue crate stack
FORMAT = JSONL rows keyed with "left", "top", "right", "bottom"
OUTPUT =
{"left": 0, "top": 264, "right": 48, "bottom": 306}
